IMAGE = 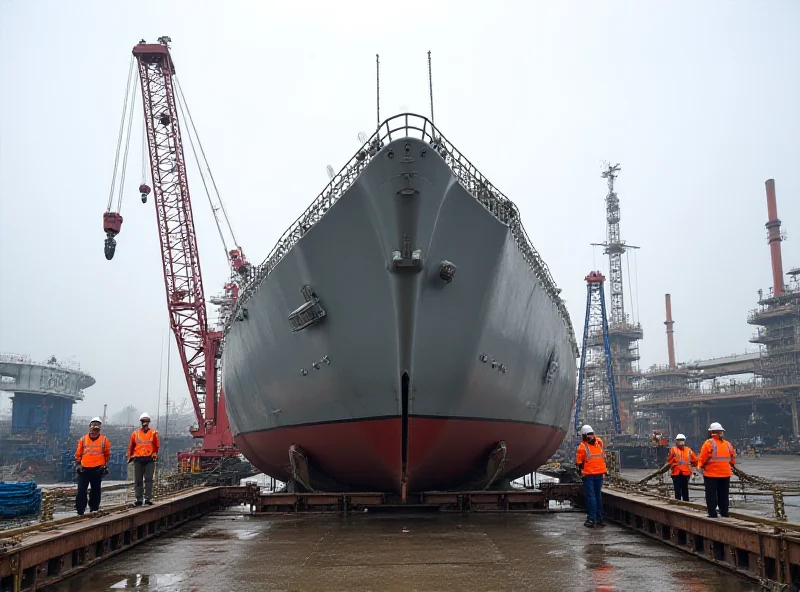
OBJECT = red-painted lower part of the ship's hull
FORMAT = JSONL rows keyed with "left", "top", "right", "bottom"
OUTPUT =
{"left": 235, "top": 417, "right": 564, "bottom": 492}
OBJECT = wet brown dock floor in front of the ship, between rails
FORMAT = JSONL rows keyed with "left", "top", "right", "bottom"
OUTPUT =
{"left": 45, "top": 509, "right": 761, "bottom": 592}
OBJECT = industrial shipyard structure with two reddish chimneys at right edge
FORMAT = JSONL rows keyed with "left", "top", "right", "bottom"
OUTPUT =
{"left": 635, "top": 179, "right": 800, "bottom": 454}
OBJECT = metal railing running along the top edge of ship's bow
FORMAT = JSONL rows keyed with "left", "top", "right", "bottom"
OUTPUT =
{"left": 225, "top": 113, "right": 578, "bottom": 357}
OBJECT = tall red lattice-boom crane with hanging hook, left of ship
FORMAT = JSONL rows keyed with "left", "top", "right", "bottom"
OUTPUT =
{"left": 103, "top": 37, "right": 249, "bottom": 470}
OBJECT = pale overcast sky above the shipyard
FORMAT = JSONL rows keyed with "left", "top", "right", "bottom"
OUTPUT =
{"left": 0, "top": 0, "right": 800, "bottom": 415}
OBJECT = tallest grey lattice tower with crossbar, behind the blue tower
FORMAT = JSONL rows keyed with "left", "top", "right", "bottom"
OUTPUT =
{"left": 592, "top": 163, "right": 644, "bottom": 423}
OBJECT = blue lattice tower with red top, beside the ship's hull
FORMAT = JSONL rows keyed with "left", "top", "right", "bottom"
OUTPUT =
{"left": 573, "top": 271, "right": 622, "bottom": 434}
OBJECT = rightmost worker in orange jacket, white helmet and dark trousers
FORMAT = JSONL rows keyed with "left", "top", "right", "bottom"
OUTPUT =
{"left": 697, "top": 421, "right": 736, "bottom": 518}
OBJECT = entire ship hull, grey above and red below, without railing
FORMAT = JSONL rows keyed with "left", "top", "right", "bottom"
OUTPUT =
{"left": 222, "top": 114, "right": 576, "bottom": 491}
